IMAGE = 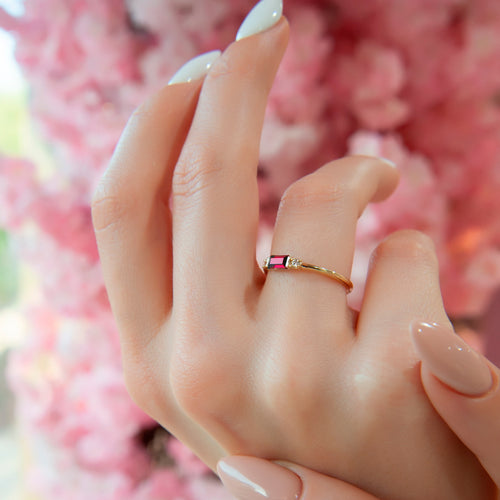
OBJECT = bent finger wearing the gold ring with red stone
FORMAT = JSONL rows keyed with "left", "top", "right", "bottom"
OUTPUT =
{"left": 262, "top": 156, "right": 399, "bottom": 345}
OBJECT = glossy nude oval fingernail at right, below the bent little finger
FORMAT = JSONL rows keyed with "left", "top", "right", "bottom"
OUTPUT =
{"left": 411, "top": 322, "right": 493, "bottom": 396}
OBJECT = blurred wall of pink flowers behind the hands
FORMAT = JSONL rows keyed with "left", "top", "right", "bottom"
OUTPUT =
{"left": 0, "top": 0, "right": 500, "bottom": 500}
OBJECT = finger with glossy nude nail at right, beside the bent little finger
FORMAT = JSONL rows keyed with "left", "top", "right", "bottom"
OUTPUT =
{"left": 411, "top": 323, "right": 500, "bottom": 486}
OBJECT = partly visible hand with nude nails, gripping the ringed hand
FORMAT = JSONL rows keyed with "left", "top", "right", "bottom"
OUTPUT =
{"left": 217, "top": 324, "right": 500, "bottom": 500}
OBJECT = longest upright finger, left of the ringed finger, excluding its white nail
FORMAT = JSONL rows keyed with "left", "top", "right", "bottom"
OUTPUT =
{"left": 172, "top": 14, "right": 288, "bottom": 307}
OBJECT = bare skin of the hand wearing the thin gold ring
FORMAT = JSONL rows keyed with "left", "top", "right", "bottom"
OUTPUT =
{"left": 92, "top": 18, "right": 493, "bottom": 500}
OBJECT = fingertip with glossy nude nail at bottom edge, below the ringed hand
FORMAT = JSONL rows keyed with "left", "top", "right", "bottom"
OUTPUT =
{"left": 217, "top": 456, "right": 377, "bottom": 500}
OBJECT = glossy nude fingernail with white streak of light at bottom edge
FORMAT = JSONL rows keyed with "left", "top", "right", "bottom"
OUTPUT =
{"left": 217, "top": 456, "right": 302, "bottom": 500}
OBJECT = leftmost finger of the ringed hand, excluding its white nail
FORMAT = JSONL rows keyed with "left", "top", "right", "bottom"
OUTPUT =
{"left": 92, "top": 81, "right": 201, "bottom": 346}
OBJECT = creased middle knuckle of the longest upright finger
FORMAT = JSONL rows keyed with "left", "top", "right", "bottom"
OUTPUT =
{"left": 172, "top": 151, "right": 221, "bottom": 200}
